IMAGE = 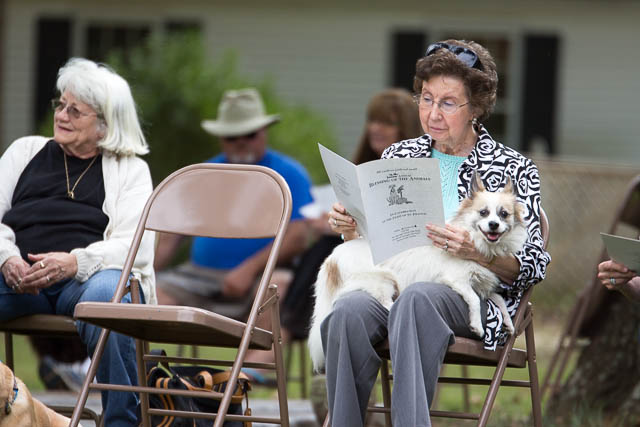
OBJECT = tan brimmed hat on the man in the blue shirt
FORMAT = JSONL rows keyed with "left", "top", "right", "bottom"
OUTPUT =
{"left": 202, "top": 88, "right": 280, "bottom": 137}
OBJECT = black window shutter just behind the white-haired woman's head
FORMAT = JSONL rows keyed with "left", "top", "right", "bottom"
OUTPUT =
{"left": 33, "top": 18, "right": 71, "bottom": 130}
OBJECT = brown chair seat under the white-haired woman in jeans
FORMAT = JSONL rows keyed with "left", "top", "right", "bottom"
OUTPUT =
{"left": 0, "top": 314, "right": 78, "bottom": 336}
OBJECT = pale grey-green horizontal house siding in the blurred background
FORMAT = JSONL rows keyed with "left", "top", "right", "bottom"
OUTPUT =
{"left": 0, "top": 0, "right": 640, "bottom": 164}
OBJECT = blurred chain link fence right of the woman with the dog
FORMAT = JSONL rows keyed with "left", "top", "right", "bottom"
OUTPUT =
{"left": 533, "top": 158, "right": 640, "bottom": 321}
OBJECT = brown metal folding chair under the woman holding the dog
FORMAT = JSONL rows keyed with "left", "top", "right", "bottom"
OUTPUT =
{"left": 323, "top": 209, "right": 549, "bottom": 427}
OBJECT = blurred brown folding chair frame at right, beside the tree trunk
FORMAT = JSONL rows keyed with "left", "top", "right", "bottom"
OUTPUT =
{"left": 541, "top": 175, "right": 640, "bottom": 400}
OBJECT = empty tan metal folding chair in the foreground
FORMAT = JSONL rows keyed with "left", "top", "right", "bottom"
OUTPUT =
{"left": 71, "top": 164, "right": 291, "bottom": 427}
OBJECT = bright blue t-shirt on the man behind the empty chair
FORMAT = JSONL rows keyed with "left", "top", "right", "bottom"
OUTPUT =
{"left": 191, "top": 150, "right": 313, "bottom": 269}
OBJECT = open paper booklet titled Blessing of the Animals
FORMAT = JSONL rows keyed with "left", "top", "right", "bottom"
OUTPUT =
{"left": 318, "top": 144, "right": 444, "bottom": 264}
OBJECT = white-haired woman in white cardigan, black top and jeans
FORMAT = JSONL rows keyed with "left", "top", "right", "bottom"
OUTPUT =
{"left": 0, "top": 58, "right": 156, "bottom": 426}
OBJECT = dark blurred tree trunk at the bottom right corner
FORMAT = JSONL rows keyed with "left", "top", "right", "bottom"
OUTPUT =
{"left": 547, "top": 293, "right": 640, "bottom": 426}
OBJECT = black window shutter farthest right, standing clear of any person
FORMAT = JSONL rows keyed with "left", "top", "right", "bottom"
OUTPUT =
{"left": 521, "top": 35, "right": 560, "bottom": 154}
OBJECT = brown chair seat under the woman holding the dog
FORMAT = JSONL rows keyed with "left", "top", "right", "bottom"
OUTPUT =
{"left": 376, "top": 337, "right": 527, "bottom": 368}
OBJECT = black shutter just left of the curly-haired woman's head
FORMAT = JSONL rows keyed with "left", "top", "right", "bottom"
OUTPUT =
{"left": 389, "top": 31, "right": 427, "bottom": 91}
